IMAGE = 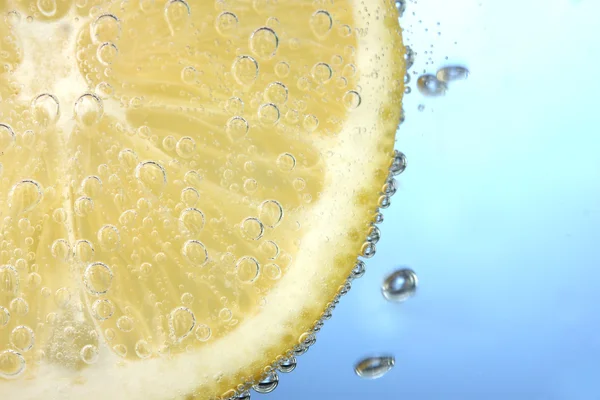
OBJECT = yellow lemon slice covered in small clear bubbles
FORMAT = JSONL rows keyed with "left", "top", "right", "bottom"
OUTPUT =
{"left": 0, "top": 0, "right": 404, "bottom": 399}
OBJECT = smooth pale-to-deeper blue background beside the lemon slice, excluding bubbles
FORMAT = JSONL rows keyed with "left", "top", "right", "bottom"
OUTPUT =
{"left": 270, "top": 0, "right": 600, "bottom": 400}
